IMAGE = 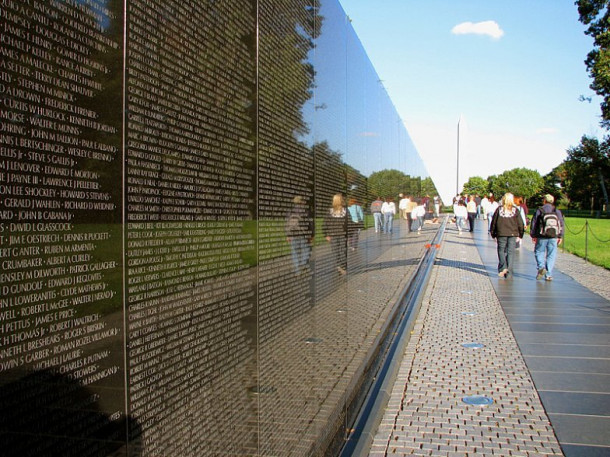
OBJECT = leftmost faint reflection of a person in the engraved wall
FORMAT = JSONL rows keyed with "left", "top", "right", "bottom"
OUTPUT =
{"left": 285, "top": 196, "right": 314, "bottom": 274}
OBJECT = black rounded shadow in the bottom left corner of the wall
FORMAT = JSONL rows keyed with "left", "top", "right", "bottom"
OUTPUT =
{"left": 0, "top": 370, "right": 141, "bottom": 457}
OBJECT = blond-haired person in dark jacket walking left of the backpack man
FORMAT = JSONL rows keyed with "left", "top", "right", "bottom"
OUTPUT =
{"left": 490, "top": 192, "right": 525, "bottom": 278}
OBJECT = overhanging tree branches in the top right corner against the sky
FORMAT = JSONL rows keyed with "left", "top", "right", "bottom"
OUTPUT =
{"left": 575, "top": 0, "right": 610, "bottom": 129}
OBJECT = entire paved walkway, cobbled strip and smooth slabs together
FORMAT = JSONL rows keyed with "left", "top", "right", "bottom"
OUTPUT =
{"left": 370, "top": 217, "right": 610, "bottom": 457}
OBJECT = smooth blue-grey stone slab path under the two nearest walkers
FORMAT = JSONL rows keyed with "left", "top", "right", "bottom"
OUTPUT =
{"left": 477, "top": 228, "right": 610, "bottom": 457}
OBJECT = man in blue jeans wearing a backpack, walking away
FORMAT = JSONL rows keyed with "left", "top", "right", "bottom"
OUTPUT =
{"left": 530, "top": 194, "right": 564, "bottom": 281}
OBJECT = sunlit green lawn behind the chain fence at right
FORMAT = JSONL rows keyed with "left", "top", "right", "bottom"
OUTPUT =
{"left": 561, "top": 217, "right": 610, "bottom": 269}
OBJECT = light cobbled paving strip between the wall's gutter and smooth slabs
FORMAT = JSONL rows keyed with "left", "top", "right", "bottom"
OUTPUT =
{"left": 370, "top": 232, "right": 562, "bottom": 457}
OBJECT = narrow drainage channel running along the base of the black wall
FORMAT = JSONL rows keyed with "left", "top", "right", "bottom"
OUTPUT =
{"left": 338, "top": 218, "right": 447, "bottom": 457}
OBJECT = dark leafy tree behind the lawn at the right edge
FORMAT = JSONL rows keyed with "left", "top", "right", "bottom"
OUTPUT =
{"left": 565, "top": 135, "right": 610, "bottom": 209}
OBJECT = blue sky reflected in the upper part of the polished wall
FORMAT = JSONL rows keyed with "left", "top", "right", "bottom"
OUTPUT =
{"left": 303, "top": 0, "right": 428, "bottom": 177}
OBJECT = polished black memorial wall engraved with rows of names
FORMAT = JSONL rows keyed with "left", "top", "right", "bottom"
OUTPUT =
{"left": 0, "top": 0, "right": 432, "bottom": 457}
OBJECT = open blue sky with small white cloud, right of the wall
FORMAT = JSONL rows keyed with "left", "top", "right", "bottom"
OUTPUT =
{"left": 340, "top": 0, "right": 604, "bottom": 198}
